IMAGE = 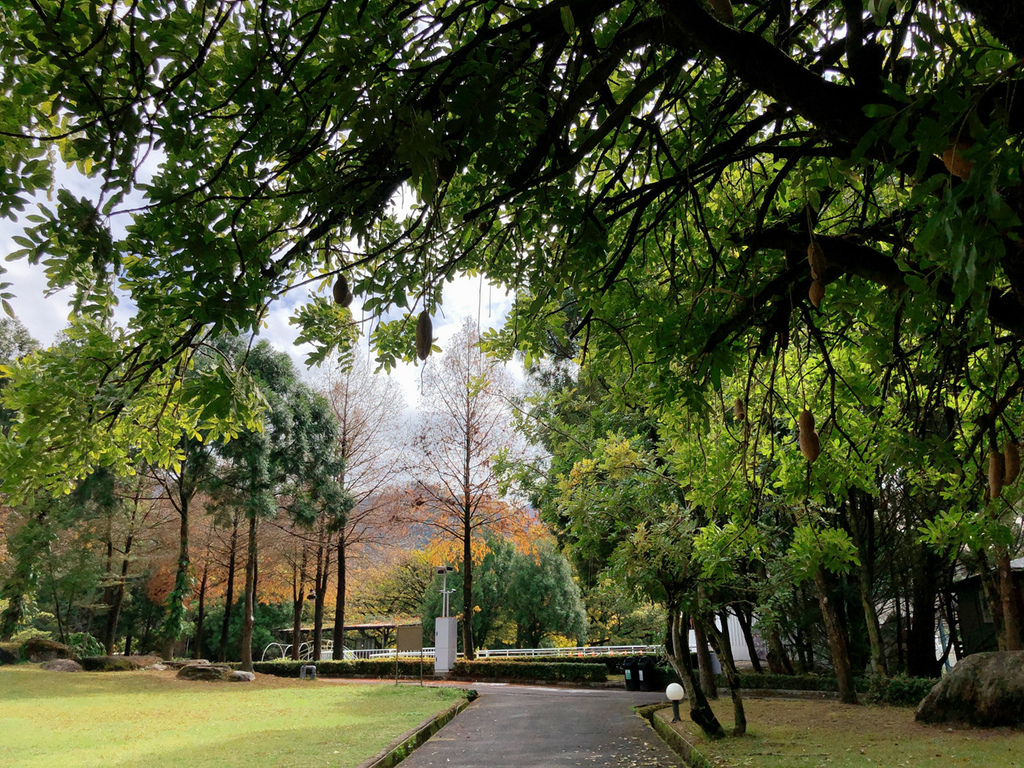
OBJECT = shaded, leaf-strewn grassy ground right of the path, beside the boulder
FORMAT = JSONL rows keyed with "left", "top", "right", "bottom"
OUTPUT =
{"left": 656, "top": 698, "right": 1024, "bottom": 768}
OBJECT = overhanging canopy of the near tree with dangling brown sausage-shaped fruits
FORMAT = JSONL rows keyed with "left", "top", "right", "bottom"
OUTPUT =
{"left": 0, "top": 0, "right": 1024, "bottom": 487}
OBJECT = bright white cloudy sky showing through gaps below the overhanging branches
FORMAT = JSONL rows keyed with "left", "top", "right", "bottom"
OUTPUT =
{"left": 0, "top": 172, "right": 522, "bottom": 408}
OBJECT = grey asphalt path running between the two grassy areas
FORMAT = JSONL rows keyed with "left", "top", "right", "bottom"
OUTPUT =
{"left": 401, "top": 683, "right": 682, "bottom": 768}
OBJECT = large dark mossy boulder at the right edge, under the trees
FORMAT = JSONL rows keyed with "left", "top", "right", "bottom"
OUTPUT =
{"left": 915, "top": 650, "right": 1024, "bottom": 727}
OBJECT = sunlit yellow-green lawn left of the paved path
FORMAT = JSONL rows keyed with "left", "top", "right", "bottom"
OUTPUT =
{"left": 0, "top": 666, "right": 462, "bottom": 768}
